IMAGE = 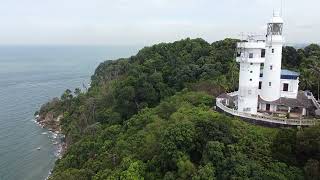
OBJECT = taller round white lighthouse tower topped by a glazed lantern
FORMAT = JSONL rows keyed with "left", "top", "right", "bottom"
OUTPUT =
{"left": 260, "top": 14, "right": 284, "bottom": 101}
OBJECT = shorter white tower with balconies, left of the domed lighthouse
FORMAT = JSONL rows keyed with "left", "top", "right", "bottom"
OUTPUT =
{"left": 236, "top": 36, "right": 265, "bottom": 114}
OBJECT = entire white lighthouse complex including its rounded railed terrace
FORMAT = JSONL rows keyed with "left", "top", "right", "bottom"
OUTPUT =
{"left": 217, "top": 14, "right": 320, "bottom": 124}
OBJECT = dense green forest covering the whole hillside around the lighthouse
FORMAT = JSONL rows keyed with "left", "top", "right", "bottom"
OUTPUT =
{"left": 40, "top": 39, "right": 320, "bottom": 180}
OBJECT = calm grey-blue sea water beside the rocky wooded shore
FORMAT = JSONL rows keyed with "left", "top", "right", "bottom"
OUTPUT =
{"left": 0, "top": 46, "right": 138, "bottom": 180}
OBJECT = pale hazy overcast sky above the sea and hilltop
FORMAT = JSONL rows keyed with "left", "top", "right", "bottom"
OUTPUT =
{"left": 0, "top": 0, "right": 320, "bottom": 45}
